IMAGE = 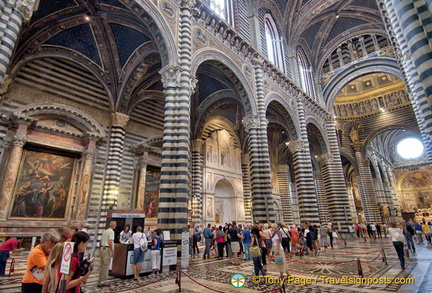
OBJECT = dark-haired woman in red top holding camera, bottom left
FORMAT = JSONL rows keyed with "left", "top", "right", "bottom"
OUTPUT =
{"left": 57, "top": 232, "right": 91, "bottom": 293}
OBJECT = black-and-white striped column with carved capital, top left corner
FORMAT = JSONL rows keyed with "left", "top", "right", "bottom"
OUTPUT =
{"left": 0, "top": 0, "right": 36, "bottom": 86}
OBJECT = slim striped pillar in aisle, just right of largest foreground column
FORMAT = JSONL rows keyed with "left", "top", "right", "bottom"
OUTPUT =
{"left": 191, "top": 139, "right": 204, "bottom": 227}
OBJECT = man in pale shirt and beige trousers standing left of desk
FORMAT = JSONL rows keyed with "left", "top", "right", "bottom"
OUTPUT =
{"left": 98, "top": 221, "right": 117, "bottom": 287}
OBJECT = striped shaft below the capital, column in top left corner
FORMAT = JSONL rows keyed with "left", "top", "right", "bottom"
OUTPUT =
{"left": 0, "top": 1, "right": 23, "bottom": 85}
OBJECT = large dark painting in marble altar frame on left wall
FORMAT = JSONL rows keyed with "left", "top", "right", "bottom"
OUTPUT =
{"left": 10, "top": 151, "right": 75, "bottom": 219}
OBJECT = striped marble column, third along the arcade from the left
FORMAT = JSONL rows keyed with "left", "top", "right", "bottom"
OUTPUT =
{"left": 287, "top": 139, "right": 319, "bottom": 224}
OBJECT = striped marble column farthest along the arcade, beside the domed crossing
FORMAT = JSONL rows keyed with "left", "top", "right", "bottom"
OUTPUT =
{"left": 321, "top": 119, "right": 352, "bottom": 231}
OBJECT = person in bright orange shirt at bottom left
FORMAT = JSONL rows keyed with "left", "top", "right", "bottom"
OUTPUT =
{"left": 21, "top": 230, "right": 60, "bottom": 293}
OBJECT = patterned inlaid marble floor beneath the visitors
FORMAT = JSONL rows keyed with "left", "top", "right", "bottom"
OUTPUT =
{"left": 0, "top": 238, "right": 432, "bottom": 293}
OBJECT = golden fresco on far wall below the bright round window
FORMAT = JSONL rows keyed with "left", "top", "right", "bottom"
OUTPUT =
{"left": 400, "top": 170, "right": 432, "bottom": 213}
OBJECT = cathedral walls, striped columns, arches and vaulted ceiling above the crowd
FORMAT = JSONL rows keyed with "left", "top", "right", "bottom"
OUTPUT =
{"left": 0, "top": 0, "right": 432, "bottom": 249}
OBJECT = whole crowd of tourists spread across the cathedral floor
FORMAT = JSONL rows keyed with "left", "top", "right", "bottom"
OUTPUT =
{"left": 0, "top": 220, "right": 432, "bottom": 293}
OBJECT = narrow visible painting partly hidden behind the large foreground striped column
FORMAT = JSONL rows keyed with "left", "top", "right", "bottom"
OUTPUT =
{"left": 144, "top": 168, "right": 160, "bottom": 218}
